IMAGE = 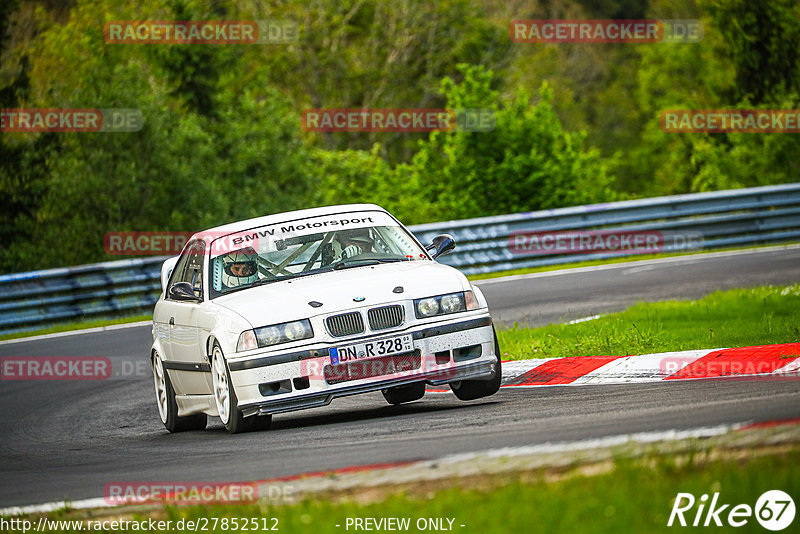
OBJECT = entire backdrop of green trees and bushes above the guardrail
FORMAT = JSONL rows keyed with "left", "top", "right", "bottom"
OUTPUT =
{"left": 0, "top": 0, "right": 800, "bottom": 272}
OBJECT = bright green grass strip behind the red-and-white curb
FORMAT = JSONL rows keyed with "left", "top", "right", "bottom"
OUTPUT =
{"left": 497, "top": 284, "right": 800, "bottom": 360}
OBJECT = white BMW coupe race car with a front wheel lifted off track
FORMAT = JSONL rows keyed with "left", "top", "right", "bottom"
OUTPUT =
{"left": 150, "top": 204, "right": 501, "bottom": 433}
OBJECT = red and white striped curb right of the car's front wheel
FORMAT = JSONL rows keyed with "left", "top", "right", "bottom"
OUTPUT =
{"left": 503, "top": 343, "right": 800, "bottom": 387}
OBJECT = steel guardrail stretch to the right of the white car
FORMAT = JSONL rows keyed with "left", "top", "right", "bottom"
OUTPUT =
{"left": 411, "top": 183, "right": 800, "bottom": 274}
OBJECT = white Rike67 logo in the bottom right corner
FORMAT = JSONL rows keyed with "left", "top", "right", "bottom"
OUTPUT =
{"left": 667, "top": 490, "right": 796, "bottom": 531}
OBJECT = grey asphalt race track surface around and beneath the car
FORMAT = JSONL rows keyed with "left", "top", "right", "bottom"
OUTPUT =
{"left": 0, "top": 247, "right": 800, "bottom": 507}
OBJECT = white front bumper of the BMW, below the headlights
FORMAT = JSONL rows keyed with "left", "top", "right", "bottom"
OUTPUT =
{"left": 228, "top": 314, "right": 498, "bottom": 416}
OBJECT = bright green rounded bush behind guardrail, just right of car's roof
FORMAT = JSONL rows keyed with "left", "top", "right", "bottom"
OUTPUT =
{"left": 398, "top": 65, "right": 613, "bottom": 220}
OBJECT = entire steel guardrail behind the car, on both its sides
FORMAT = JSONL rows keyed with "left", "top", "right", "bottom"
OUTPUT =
{"left": 0, "top": 183, "right": 800, "bottom": 334}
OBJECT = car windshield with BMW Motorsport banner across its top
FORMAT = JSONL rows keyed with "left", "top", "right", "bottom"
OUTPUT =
{"left": 209, "top": 211, "right": 428, "bottom": 298}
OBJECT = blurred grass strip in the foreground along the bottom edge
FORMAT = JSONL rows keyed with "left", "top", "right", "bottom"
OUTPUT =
{"left": 26, "top": 444, "right": 800, "bottom": 534}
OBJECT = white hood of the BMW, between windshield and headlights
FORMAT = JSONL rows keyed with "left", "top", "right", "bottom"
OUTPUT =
{"left": 213, "top": 261, "right": 470, "bottom": 328}
